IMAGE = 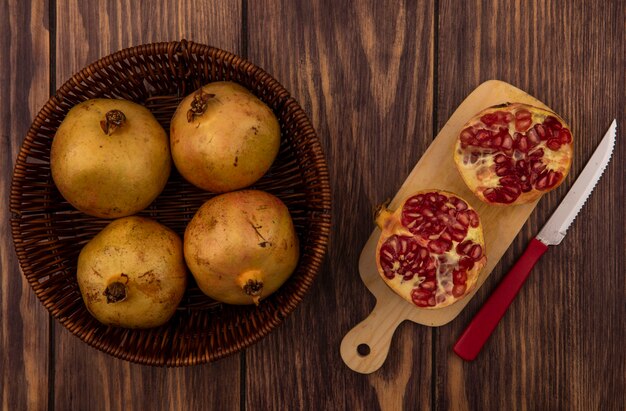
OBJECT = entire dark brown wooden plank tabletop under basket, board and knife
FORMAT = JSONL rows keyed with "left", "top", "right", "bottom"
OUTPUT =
{"left": 0, "top": 0, "right": 626, "bottom": 410}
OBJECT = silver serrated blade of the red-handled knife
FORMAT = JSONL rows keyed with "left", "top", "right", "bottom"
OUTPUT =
{"left": 536, "top": 120, "right": 617, "bottom": 245}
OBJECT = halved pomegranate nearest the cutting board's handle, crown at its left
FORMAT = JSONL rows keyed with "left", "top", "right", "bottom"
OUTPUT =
{"left": 376, "top": 190, "right": 487, "bottom": 308}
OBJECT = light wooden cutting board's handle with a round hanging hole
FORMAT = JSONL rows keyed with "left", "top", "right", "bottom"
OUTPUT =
{"left": 340, "top": 299, "right": 415, "bottom": 374}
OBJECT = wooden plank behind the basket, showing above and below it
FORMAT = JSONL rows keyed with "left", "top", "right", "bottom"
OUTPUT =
{"left": 54, "top": 0, "right": 241, "bottom": 410}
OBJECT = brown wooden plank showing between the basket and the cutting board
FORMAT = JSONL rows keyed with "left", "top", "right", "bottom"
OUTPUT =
{"left": 245, "top": 1, "right": 434, "bottom": 409}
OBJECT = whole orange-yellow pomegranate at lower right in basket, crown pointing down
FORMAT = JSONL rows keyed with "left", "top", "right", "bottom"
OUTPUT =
{"left": 184, "top": 190, "right": 299, "bottom": 304}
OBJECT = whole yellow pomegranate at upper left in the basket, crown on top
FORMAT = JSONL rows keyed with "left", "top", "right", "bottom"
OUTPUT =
{"left": 50, "top": 99, "right": 171, "bottom": 218}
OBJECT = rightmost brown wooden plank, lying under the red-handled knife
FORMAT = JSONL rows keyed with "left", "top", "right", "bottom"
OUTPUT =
{"left": 435, "top": 0, "right": 626, "bottom": 410}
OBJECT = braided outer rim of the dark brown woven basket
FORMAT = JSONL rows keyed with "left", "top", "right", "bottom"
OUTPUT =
{"left": 9, "top": 39, "right": 332, "bottom": 366}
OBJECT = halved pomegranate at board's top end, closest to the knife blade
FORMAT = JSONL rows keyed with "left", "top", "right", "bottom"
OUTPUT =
{"left": 454, "top": 103, "right": 573, "bottom": 205}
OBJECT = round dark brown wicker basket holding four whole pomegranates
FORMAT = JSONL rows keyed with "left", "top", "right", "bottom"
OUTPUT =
{"left": 10, "top": 40, "right": 331, "bottom": 366}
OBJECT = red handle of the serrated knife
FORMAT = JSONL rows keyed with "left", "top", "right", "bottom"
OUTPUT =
{"left": 454, "top": 238, "right": 548, "bottom": 361}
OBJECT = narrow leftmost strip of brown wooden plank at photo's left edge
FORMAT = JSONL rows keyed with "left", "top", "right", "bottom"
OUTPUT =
{"left": 0, "top": 0, "right": 50, "bottom": 410}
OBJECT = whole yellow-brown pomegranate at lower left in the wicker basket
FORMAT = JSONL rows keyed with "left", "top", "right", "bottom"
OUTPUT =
{"left": 77, "top": 216, "right": 187, "bottom": 328}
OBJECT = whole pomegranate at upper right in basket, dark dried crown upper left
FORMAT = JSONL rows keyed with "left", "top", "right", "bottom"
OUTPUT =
{"left": 170, "top": 82, "right": 280, "bottom": 193}
